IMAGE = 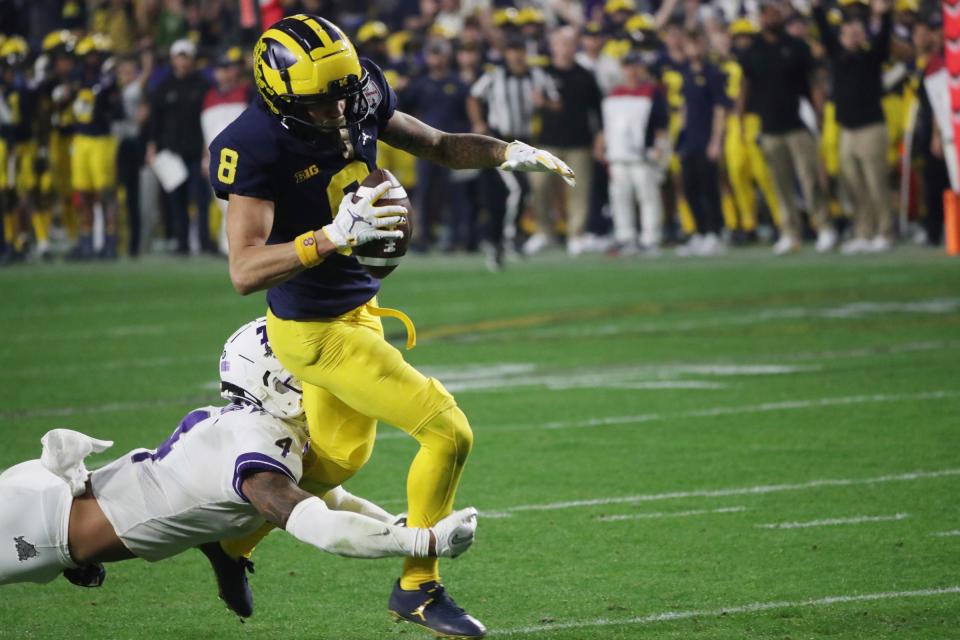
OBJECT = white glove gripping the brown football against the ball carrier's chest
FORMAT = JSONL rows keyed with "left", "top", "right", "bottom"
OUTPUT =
{"left": 321, "top": 182, "right": 407, "bottom": 255}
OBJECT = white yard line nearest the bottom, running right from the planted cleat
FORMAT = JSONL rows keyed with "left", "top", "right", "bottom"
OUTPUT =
{"left": 490, "top": 586, "right": 960, "bottom": 636}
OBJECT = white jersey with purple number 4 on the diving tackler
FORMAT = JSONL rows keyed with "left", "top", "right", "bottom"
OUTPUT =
{"left": 90, "top": 405, "right": 308, "bottom": 562}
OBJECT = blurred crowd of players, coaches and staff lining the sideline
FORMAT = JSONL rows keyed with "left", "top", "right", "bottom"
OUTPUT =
{"left": 0, "top": 0, "right": 949, "bottom": 269}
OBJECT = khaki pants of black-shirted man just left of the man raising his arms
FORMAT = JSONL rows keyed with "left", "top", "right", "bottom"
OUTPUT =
{"left": 760, "top": 129, "right": 829, "bottom": 243}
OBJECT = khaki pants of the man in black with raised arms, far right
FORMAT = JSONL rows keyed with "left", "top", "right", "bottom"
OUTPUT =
{"left": 840, "top": 122, "right": 893, "bottom": 240}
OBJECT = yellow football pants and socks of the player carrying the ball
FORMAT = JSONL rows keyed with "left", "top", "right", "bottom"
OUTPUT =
{"left": 224, "top": 299, "right": 473, "bottom": 589}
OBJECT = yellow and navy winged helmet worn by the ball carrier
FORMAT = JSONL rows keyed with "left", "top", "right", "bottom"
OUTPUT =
{"left": 253, "top": 14, "right": 376, "bottom": 136}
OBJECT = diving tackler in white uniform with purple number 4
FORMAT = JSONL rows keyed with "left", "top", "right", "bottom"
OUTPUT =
{"left": 0, "top": 318, "right": 476, "bottom": 604}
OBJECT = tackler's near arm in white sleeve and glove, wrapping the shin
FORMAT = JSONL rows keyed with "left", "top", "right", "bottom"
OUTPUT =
{"left": 241, "top": 471, "right": 476, "bottom": 558}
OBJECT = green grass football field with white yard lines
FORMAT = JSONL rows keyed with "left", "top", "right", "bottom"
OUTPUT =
{"left": 0, "top": 249, "right": 960, "bottom": 640}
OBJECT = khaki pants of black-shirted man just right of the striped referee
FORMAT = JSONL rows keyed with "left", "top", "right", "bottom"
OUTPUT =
{"left": 529, "top": 147, "right": 593, "bottom": 238}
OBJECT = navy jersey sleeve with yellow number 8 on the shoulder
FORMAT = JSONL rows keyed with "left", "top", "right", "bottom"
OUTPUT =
{"left": 210, "top": 105, "right": 276, "bottom": 201}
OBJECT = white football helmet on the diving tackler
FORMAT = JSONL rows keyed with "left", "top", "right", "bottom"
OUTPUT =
{"left": 220, "top": 318, "right": 303, "bottom": 420}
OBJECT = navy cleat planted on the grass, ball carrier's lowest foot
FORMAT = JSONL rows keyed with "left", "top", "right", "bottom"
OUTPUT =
{"left": 387, "top": 580, "right": 487, "bottom": 639}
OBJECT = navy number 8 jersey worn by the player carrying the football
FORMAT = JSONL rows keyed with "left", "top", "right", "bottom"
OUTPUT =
{"left": 210, "top": 58, "right": 397, "bottom": 320}
